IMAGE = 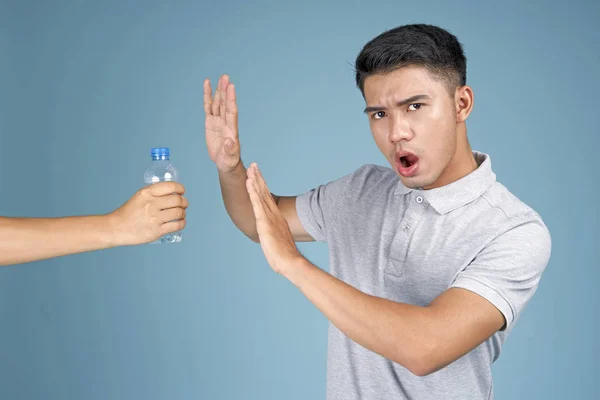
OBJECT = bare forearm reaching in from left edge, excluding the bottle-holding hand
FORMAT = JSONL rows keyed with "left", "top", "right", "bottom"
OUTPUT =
{"left": 0, "top": 215, "right": 115, "bottom": 265}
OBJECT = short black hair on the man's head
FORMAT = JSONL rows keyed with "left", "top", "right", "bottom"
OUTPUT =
{"left": 354, "top": 24, "right": 467, "bottom": 96}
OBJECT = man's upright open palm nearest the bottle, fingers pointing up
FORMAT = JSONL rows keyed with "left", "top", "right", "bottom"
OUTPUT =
{"left": 204, "top": 75, "right": 240, "bottom": 172}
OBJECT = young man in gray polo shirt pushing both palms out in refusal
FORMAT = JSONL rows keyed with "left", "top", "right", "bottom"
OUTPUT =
{"left": 204, "top": 25, "right": 551, "bottom": 400}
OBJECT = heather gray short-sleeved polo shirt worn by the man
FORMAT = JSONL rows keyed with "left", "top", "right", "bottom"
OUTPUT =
{"left": 296, "top": 152, "right": 551, "bottom": 400}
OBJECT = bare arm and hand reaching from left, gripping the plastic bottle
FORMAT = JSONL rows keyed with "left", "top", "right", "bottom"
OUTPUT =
{"left": 0, "top": 182, "right": 188, "bottom": 265}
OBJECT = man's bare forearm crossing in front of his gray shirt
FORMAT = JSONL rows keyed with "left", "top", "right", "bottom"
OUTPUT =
{"left": 285, "top": 258, "right": 434, "bottom": 375}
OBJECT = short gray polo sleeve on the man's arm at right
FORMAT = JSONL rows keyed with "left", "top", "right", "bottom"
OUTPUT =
{"left": 451, "top": 218, "right": 551, "bottom": 330}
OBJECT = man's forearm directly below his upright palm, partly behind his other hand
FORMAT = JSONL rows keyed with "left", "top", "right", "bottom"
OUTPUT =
{"left": 219, "top": 161, "right": 277, "bottom": 242}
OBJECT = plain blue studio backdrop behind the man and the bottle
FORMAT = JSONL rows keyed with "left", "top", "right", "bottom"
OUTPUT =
{"left": 0, "top": 1, "right": 600, "bottom": 399}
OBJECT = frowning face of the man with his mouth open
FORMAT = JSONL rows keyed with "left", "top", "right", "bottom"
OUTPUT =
{"left": 364, "top": 66, "right": 457, "bottom": 188}
